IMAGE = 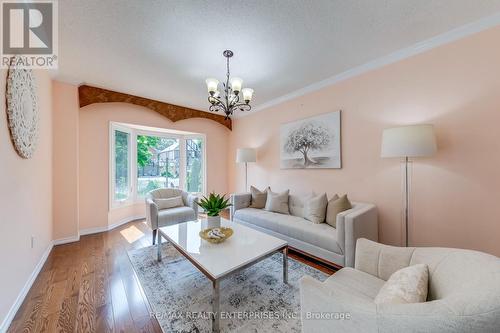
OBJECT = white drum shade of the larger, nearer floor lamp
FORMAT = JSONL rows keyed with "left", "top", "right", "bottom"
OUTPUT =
{"left": 381, "top": 125, "right": 437, "bottom": 157}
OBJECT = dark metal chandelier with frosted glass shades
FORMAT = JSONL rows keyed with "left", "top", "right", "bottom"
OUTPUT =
{"left": 205, "top": 50, "right": 253, "bottom": 119}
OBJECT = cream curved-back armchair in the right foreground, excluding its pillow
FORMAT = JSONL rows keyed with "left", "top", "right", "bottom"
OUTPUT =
{"left": 300, "top": 239, "right": 500, "bottom": 333}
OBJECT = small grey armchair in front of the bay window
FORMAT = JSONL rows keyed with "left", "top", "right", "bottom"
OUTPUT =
{"left": 146, "top": 188, "right": 198, "bottom": 245}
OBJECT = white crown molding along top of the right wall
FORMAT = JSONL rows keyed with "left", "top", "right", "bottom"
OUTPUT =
{"left": 240, "top": 13, "right": 500, "bottom": 119}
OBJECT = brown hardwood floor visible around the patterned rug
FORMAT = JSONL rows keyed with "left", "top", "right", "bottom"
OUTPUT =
{"left": 8, "top": 217, "right": 335, "bottom": 333}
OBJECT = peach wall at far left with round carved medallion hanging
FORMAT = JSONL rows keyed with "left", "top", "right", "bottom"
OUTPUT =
{"left": 0, "top": 70, "right": 52, "bottom": 324}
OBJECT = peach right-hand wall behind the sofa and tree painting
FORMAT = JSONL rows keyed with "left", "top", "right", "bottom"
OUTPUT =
{"left": 228, "top": 28, "right": 500, "bottom": 255}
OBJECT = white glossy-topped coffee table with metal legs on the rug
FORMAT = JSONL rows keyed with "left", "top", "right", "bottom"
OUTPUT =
{"left": 157, "top": 219, "right": 288, "bottom": 332}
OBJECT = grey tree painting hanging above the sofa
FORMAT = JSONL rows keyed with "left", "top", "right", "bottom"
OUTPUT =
{"left": 280, "top": 111, "right": 341, "bottom": 169}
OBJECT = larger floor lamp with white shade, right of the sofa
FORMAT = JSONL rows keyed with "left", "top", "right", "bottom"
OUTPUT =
{"left": 381, "top": 125, "right": 437, "bottom": 246}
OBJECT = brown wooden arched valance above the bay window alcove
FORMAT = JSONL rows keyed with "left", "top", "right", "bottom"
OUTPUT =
{"left": 78, "top": 85, "right": 232, "bottom": 130}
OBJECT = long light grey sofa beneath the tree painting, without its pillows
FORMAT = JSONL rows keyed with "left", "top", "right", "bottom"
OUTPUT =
{"left": 230, "top": 193, "right": 378, "bottom": 267}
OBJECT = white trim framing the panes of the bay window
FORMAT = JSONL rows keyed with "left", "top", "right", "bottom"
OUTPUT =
{"left": 109, "top": 121, "right": 207, "bottom": 210}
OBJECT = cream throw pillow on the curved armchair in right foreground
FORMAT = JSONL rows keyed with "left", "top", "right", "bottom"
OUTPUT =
{"left": 374, "top": 264, "right": 429, "bottom": 304}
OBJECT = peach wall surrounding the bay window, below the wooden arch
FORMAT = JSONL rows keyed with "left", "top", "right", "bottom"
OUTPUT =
{"left": 79, "top": 103, "right": 229, "bottom": 230}
